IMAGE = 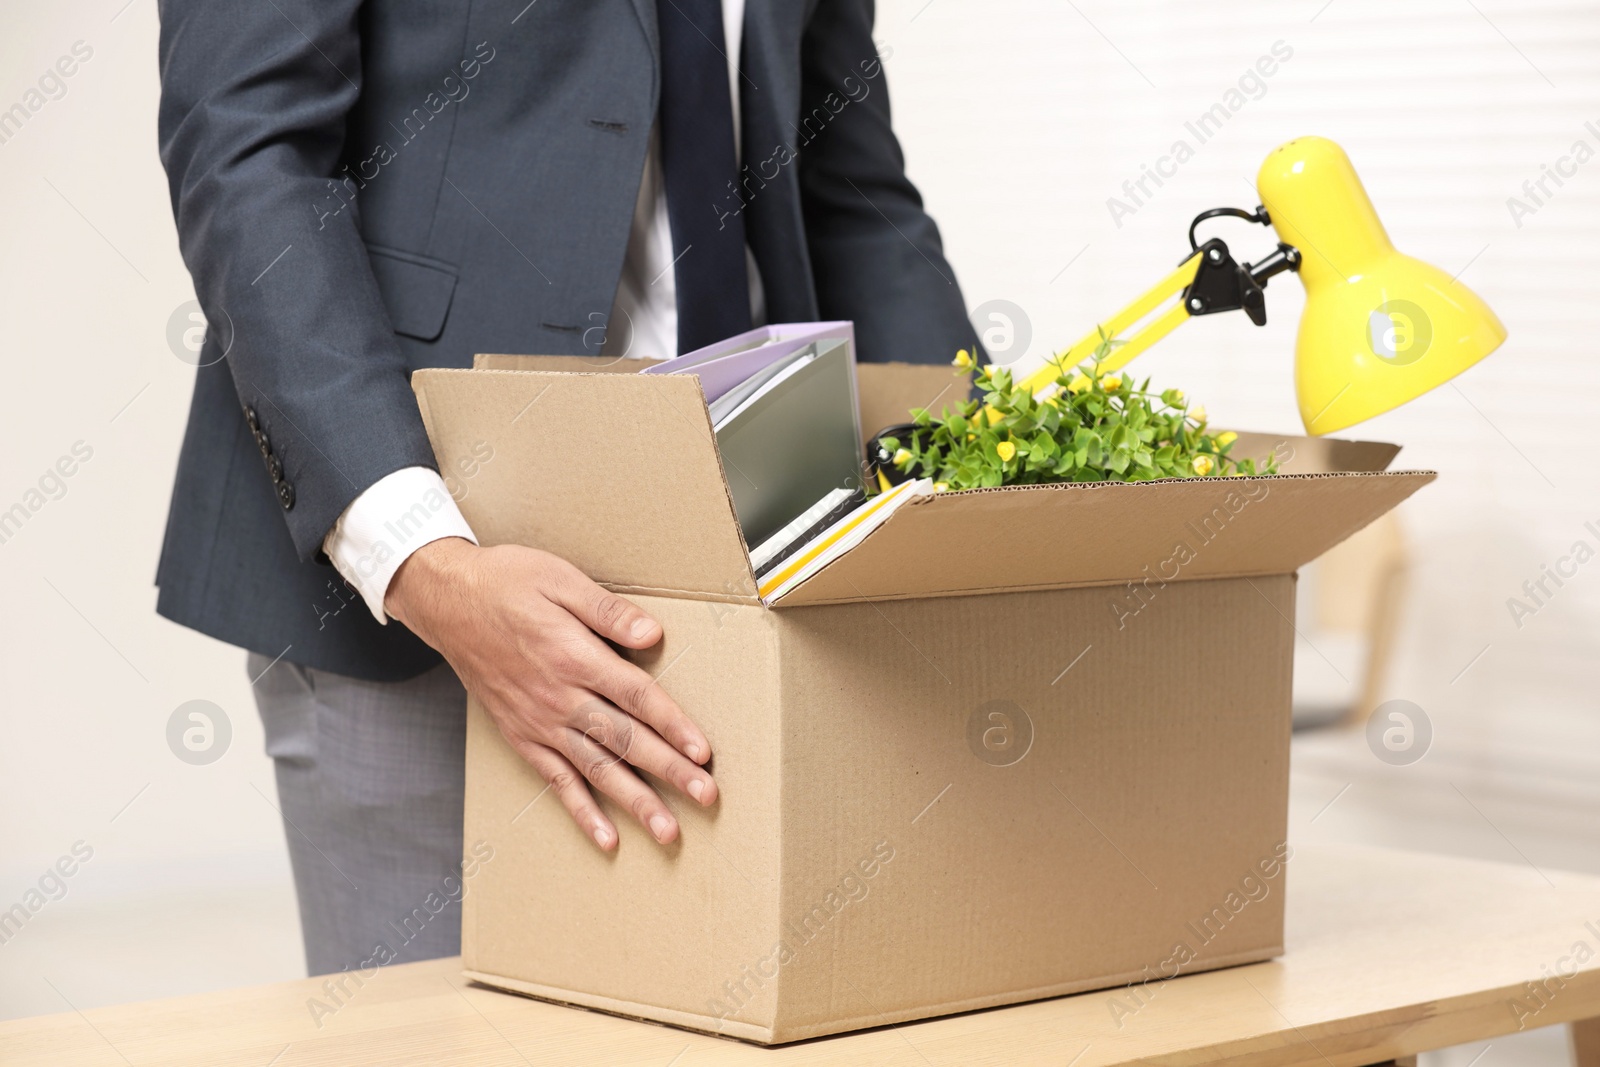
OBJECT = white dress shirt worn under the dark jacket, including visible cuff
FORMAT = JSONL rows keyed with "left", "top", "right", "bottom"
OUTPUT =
{"left": 322, "top": 0, "right": 765, "bottom": 624}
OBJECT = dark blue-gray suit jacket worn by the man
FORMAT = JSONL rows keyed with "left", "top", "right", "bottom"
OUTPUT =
{"left": 157, "top": 0, "right": 973, "bottom": 680}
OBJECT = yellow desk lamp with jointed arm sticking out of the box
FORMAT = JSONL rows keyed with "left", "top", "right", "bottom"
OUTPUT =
{"left": 1022, "top": 138, "right": 1506, "bottom": 435}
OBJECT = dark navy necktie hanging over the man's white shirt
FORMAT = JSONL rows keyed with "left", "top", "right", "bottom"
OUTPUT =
{"left": 656, "top": 0, "right": 750, "bottom": 354}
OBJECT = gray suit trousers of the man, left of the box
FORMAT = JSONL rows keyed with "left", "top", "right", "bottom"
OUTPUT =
{"left": 248, "top": 653, "right": 467, "bottom": 974}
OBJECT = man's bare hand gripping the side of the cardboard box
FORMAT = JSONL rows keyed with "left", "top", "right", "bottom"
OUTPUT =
{"left": 384, "top": 537, "right": 717, "bottom": 849}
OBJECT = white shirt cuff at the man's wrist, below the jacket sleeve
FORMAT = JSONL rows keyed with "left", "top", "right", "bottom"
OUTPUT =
{"left": 322, "top": 467, "right": 478, "bottom": 625}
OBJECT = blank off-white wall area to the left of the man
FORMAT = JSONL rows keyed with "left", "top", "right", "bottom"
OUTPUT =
{"left": 0, "top": 0, "right": 301, "bottom": 1016}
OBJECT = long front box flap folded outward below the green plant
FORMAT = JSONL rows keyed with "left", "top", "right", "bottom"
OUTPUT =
{"left": 774, "top": 470, "right": 1435, "bottom": 608}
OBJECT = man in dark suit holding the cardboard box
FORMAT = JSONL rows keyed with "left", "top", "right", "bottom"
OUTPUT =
{"left": 157, "top": 0, "right": 974, "bottom": 973}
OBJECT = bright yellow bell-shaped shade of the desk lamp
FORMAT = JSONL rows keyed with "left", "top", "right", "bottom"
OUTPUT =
{"left": 1256, "top": 138, "right": 1506, "bottom": 434}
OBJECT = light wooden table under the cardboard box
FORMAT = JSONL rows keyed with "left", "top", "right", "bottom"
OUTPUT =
{"left": 0, "top": 845, "right": 1600, "bottom": 1067}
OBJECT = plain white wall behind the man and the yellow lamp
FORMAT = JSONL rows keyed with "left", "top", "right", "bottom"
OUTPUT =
{"left": 0, "top": 0, "right": 1600, "bottom": 1036}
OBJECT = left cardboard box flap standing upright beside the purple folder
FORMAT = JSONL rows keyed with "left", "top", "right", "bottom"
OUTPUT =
{"left": 411, "top": 367, "right": 755, "bottom": 601}
